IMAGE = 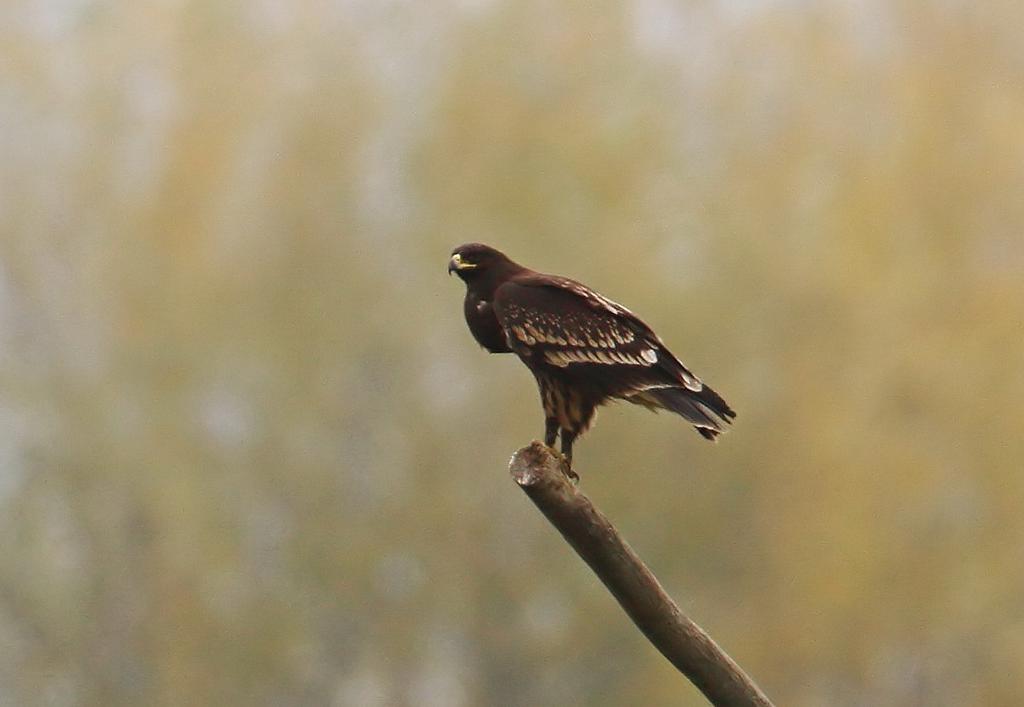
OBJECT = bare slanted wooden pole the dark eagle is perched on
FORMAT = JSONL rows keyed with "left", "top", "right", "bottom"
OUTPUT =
{"left": 509, "top": 442, "right": 771, "bottom": 707}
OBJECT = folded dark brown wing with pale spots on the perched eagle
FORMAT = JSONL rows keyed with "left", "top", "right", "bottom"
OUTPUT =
{"left": 494, "top": 274, "right": 703, "bottom": 391}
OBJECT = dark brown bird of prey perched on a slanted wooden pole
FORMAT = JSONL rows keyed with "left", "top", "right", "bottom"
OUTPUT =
{"left": 449, "top": 243, "right": 736, "bottom": 468}
